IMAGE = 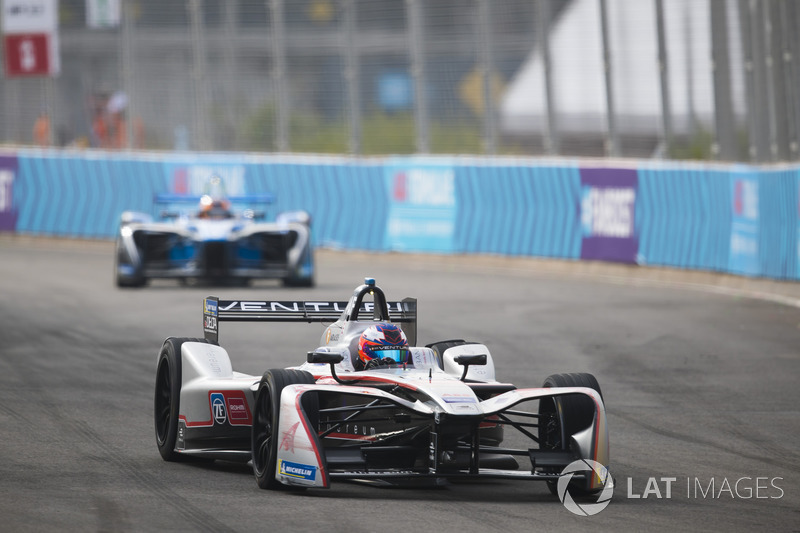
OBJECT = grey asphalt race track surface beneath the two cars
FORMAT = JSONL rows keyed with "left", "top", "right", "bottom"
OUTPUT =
{"left": 0, "top": 237, "right": 800, "bottom": 533}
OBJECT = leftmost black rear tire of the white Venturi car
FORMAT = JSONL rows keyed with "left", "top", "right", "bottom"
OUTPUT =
{"left": 153, "top": 337, "right": 206, "bottom": 461}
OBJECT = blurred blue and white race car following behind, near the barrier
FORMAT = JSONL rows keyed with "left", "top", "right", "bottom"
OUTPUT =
{"left": 114, "top": 178, "right": 314, "bottom": 287}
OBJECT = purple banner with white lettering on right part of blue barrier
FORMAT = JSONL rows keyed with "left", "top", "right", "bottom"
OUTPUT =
{"left": 580, "top": 168, "right": 639, "bottom": 263}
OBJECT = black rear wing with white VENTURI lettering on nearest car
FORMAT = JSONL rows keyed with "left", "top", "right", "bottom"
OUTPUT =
{"left": 203, "top": 296, "right": 417, "bottom": 346}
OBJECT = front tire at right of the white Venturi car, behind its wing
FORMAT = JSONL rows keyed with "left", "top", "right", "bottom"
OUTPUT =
{"left": 539, "top": 373, "right": 603, "bottom": 494}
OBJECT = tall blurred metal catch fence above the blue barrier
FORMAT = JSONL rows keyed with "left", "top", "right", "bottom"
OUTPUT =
{"left": 0, "top": 0, "right": 800, "bottom": 162}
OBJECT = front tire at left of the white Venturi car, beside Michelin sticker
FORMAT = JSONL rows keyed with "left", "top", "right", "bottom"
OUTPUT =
{"left": 251, "top": 369, "right": 316, "bottom": 490}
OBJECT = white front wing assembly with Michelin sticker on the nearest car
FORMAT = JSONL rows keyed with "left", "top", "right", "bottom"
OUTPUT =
{"left": 273, "top": 385, "right": 609, "bottom": 490}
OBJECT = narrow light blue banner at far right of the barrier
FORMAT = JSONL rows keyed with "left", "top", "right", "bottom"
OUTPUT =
{"left": 728, "top": 172, "right": 760, "bottom": 276}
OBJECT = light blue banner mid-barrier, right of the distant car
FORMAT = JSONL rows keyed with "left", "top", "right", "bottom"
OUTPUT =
{"left": 384, "top": 158, "right": 456, "bottom": 253}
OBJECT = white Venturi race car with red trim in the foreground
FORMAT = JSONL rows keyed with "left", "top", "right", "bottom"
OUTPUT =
{"left": 155, "top": 278, "right": 610, "bottom": 493}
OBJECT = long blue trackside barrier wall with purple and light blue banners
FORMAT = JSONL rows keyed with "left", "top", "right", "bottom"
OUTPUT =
{"left": 0, "top": 150, "right": 800, "bottom": 280}
